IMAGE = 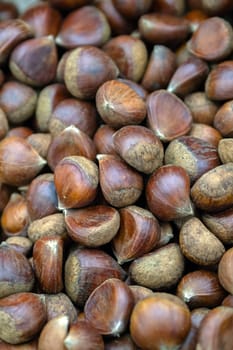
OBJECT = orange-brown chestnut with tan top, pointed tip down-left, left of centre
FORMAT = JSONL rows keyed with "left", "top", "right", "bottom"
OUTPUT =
{"left": 54, "top": 156, "right": 99, "bottom": 209}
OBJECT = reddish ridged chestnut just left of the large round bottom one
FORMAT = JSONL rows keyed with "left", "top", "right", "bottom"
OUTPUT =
{"left": 84, "top": 278, "right": 134, "bottom": 336}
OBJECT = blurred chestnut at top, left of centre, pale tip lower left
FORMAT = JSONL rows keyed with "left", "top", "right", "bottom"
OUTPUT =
{"left": 56, "top": 5, "right": 111, "bottom": 49}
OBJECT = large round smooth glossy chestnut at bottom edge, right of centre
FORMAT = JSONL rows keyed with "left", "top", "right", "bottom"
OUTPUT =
{"left": 130, "top": 293, "right": 191, "bottom": 350}
